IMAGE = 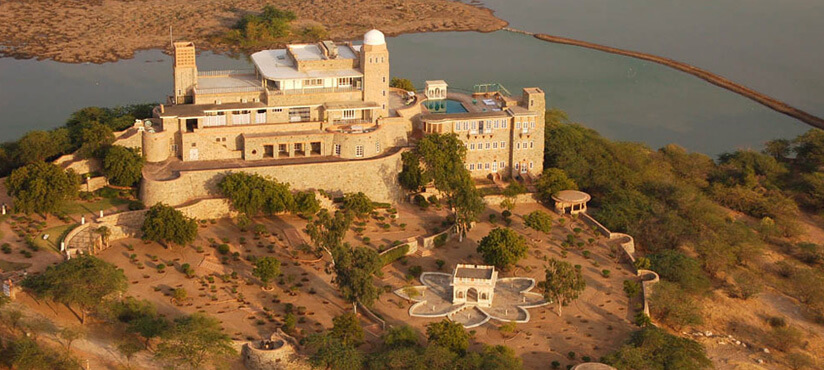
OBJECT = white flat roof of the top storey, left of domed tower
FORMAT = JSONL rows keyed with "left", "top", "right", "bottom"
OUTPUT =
{"left": 252, "top": 44, "right": 363, "bottom": 80}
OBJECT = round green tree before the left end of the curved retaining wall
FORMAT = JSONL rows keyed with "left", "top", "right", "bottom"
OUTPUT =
{"left": 140, "top": 203, "right": 197, "bottom": 246}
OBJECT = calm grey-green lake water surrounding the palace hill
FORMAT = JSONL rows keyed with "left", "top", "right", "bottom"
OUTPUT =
{"left": 0, "top": 0, "right": 824, "bottom": 155}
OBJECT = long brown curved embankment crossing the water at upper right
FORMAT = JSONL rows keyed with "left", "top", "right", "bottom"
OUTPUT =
{"left": 504, "top": 27, "right": 824, "bottom": 129}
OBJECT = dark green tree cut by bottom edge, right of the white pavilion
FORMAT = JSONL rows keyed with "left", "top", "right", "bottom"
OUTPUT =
{"left": 603, "top": 325, "right": 712, "bottom": 370}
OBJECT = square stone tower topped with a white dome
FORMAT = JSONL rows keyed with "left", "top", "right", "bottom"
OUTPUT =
{"left": 360, "top": 30, "right": 389, "bottom": 117}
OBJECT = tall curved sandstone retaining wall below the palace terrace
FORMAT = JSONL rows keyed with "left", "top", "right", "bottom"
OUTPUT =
{"left": 140, "top": 149, "right": 404, "bottom": 207}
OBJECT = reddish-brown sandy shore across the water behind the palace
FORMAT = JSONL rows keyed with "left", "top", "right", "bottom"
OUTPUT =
{"left": 0, "top": 0, "right": 506, "bottom": 63}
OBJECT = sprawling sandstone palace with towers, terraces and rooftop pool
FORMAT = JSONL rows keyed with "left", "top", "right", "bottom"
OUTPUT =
{"left": 134, "top": 30, "right": 546, "bottom": 205}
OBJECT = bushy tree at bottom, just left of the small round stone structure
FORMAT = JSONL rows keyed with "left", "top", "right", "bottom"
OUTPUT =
{"left": 156, "top": 313, "right": 236, "bottom": 368}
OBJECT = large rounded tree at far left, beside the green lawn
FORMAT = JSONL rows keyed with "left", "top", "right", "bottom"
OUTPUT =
{"left": 6, "top": 162, "right": 79, "bottom": 214}
